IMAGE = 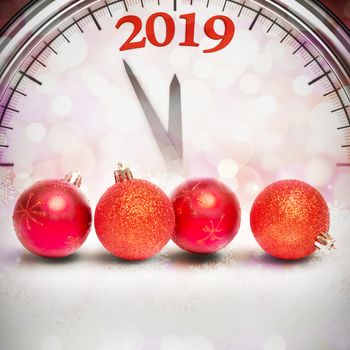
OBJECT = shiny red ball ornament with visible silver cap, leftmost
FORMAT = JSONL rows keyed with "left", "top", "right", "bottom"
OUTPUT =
{"left": 13, "top": 172, "right": 92, "bottom": 258}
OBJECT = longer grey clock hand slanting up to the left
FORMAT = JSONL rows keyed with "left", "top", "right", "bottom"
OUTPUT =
{"left": 123, "top": 60, "right": 182, "bottom": 164}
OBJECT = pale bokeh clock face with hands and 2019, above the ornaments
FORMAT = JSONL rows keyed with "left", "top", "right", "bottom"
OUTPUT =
{"left": 0, "top": 0, "right": 349, "bottom": 208}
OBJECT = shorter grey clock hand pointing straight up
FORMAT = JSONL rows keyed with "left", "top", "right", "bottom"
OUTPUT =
{"left": 168, "top": 74, "right": 183, "bottom": 158}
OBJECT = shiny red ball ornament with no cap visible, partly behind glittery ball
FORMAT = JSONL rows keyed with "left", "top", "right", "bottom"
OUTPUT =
{"left": 171, "top": 178, "right": 241, "bottom": 254}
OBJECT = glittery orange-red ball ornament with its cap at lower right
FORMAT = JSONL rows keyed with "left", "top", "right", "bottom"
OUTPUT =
{"left": 250, "top": 180, "right": 334, "bottom": 259}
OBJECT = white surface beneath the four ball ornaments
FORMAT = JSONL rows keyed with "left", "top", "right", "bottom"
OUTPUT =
{"left": 0, "top": 208, "right": 350, "bottom": 350}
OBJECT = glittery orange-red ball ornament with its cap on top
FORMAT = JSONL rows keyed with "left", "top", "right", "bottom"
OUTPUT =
{"left": 95, "top": 164, "right": 175, "bottom": 260}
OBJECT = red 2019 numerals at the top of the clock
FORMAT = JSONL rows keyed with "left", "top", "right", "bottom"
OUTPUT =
{"left": 115, "top": 12, "right": 235, "bottom": 53}
